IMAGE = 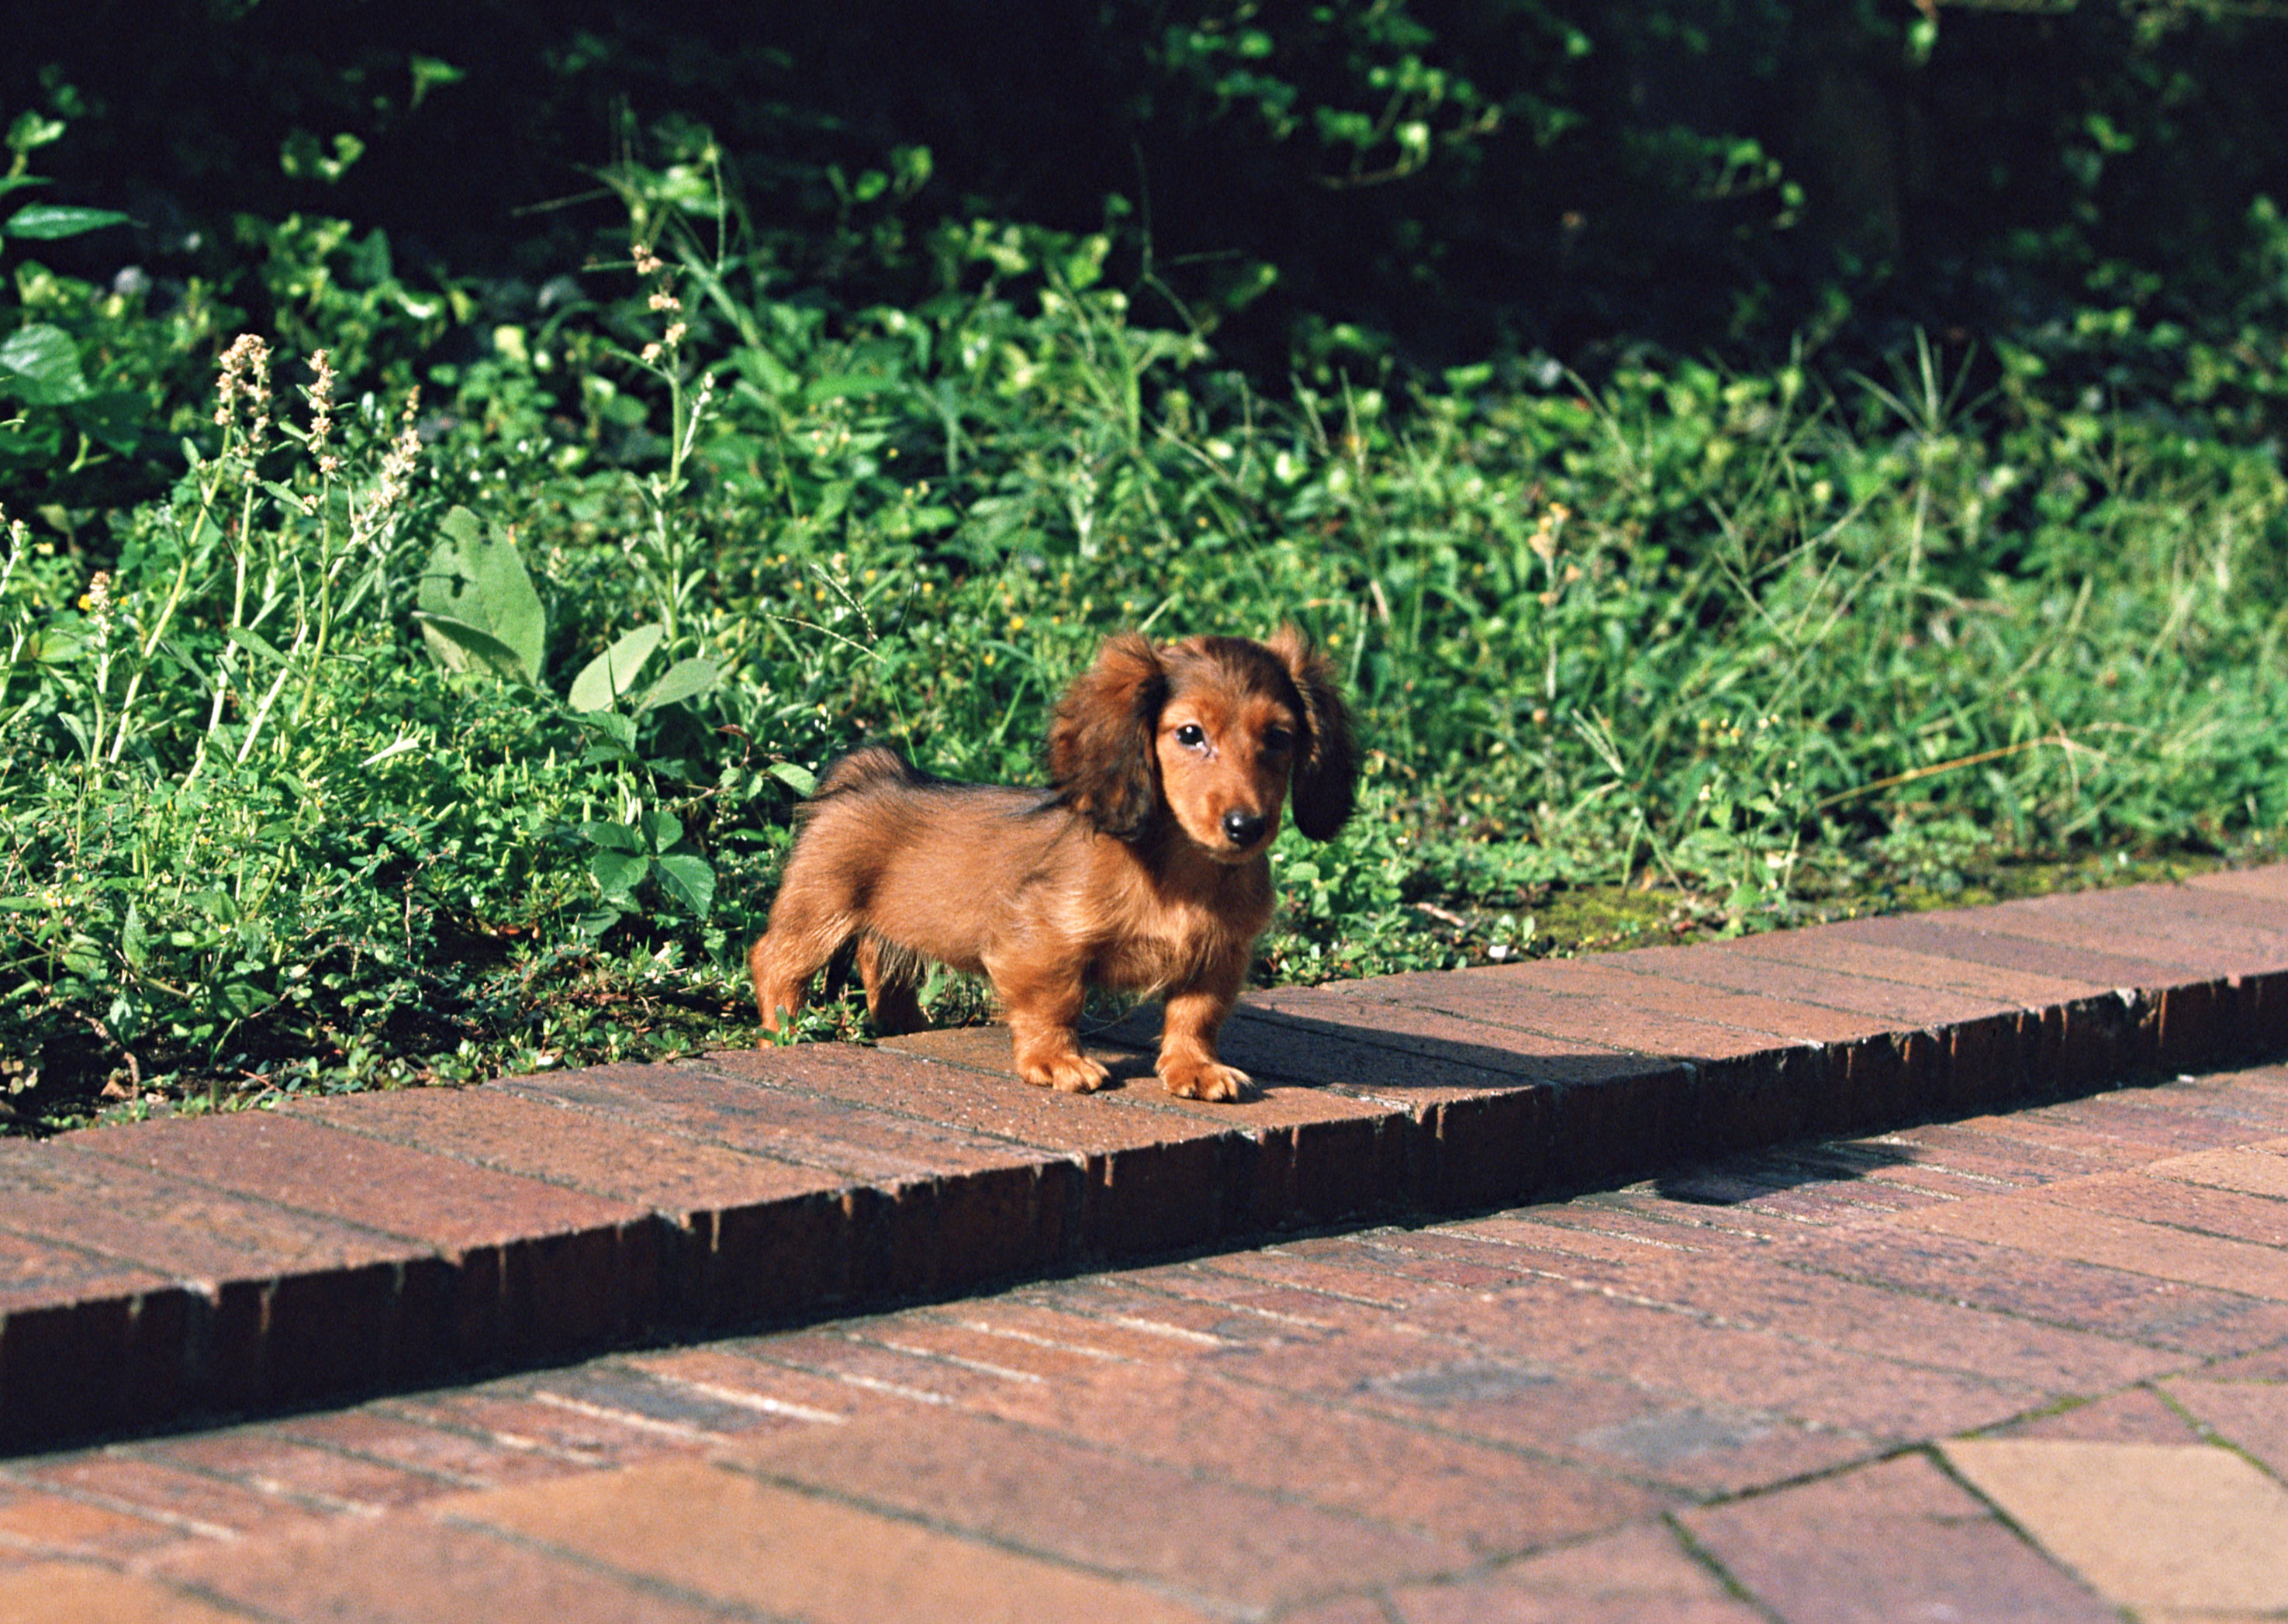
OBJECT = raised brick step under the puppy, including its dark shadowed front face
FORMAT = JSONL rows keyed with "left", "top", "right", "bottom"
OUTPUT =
{"left": 0, "top": 865, "right": 2288, "bottom": 1453}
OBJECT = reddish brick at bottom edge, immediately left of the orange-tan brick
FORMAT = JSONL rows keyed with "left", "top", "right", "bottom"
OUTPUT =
{"left": 161, "top": 1514, "right": 723, "bottom": 1624}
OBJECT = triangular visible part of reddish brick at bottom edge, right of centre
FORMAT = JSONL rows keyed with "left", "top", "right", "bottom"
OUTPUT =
{"left": 1373, "top": 1523, "right": 1764, "bottom": 1624}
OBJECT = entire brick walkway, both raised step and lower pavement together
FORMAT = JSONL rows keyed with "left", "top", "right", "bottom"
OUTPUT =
{"left": 0, "top": 869, "right": 2288, "bottom": 1624}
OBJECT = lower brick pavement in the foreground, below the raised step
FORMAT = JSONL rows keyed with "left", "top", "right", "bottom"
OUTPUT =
{"left": 0, "top": 1066, "right": 2288, "bottom": 1624}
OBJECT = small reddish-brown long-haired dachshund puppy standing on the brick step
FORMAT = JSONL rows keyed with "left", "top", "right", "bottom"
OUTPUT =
{"left": 746, "top": 629, "right": 1357, "bottom": 1101}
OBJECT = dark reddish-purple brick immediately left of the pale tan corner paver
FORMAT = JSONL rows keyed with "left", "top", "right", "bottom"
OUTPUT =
{"left": 1679, "top": 1455, "right": 2117, "bottom": 1624}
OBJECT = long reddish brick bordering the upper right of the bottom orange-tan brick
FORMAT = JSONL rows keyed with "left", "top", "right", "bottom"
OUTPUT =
{"left": 718, "top": 1407, "right": 1467, "bottom": 1608}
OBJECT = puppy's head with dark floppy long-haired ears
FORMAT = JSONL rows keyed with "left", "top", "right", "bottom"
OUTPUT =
{"left": 1048, "top": 627, "right": 1359, "bottom": 862}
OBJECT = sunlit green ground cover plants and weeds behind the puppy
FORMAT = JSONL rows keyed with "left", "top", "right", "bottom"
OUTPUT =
{"left": 0, "top": 12, "right": 2288, "bottom": 1130}
